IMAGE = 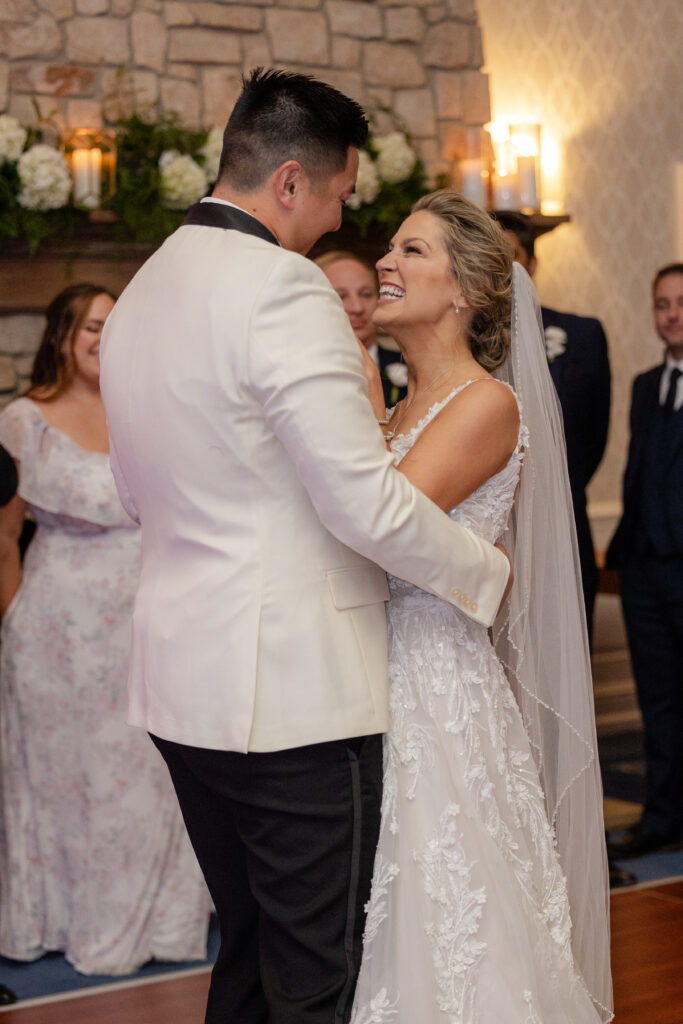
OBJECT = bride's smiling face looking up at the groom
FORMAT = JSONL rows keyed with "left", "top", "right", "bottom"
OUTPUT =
{"left": 373, "top": 210, "right": 467, "bottom": 334}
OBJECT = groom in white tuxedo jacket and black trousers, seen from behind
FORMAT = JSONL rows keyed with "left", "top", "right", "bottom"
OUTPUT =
{"left": 101, "top": 71, "right": 509, "bottom": 1024}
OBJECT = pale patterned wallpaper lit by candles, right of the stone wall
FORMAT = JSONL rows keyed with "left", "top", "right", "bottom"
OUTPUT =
{"left": 477, "top": 0, "right": 683, "bottom": 516}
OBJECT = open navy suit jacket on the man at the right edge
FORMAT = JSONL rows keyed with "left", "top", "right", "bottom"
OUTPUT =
{"left": 607, "top": 362, "right": 683, "bottom": 568}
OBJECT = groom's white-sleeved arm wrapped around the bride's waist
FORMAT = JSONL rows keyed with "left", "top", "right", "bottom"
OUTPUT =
{"left": 249, "top": 254, "right": 509, "bottom": 626}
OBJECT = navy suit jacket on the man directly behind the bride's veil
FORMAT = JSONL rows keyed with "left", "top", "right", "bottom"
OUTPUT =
{"left": 541, "top": 307, "right": 611, "bottom": 604}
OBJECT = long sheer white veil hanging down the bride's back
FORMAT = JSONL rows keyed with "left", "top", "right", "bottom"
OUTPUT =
{"left": 494, "top": 263, "right": 613, "bottom": 1022}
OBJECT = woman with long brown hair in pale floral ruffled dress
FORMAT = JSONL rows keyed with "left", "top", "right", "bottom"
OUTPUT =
{"left": 0, "top": 284, "right": 209, "bottom": 975}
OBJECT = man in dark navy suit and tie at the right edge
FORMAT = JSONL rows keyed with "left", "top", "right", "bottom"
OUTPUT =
{"left": 607, "top": 263, "right": 683, "bottom": 857}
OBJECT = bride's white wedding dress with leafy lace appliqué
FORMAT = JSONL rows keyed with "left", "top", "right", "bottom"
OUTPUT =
{"left": 351, "top": 382, "right": 600, "bottom": 1024}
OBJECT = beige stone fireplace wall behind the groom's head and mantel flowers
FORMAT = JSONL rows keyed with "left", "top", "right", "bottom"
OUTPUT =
{"left": 0, "top": 0, "right": 489, "bottom": 402}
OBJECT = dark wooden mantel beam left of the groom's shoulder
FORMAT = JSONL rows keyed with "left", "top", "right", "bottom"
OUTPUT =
{"left": 0, "top": 224, "right": 157, "bottom": 316}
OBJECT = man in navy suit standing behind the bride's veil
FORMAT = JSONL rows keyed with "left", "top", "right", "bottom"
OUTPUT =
{"left": 496, "top": 212, "right": 610, "bottom": 636}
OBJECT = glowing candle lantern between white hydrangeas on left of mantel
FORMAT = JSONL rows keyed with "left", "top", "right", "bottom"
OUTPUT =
{"left": 62, "top": 128, "right": 116, "bottom": 210}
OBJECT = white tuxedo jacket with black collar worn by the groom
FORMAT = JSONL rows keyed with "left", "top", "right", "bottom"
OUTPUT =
{"left": 100, "top": 204, "right": 508, "bottom": 752}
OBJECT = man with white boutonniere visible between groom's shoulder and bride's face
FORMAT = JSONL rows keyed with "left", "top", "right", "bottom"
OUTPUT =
{"left": 315, "top": 249, "right": 408, "bottom": 409}
